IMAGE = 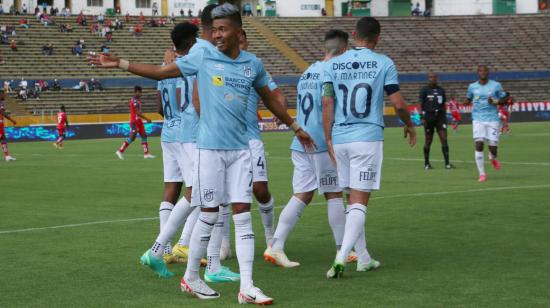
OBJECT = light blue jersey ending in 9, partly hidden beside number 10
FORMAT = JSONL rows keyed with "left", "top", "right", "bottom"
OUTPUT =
{"left": 290, "top": 61, "right": 327, "bottom": 153}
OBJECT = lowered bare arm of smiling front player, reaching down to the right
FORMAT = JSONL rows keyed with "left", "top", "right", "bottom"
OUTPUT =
{"left": 256, "top": 86, "right": 317, "bottom": 153}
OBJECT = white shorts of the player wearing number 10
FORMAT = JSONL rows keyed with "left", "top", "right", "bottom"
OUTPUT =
{"left": 334, "top": 141, "right": 384, "bottom": 192}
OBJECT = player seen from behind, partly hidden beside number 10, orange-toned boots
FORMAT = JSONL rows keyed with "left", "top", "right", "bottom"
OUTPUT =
{"left": 264, "top": 30, "right": 354, "bottom": 267}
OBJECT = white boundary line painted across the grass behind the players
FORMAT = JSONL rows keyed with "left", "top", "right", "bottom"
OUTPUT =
{"left": 0, "top": 185, "right": 550, "bottom": 234}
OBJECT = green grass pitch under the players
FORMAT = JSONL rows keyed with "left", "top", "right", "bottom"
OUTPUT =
{"left": 0, "top": 123, "right": 550, "bottom": 307}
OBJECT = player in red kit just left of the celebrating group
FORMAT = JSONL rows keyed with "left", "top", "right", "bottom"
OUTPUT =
{"left": 115, "top": 86, "right": 155, "bottom": 159}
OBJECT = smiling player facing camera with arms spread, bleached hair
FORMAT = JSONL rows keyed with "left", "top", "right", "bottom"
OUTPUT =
{"left": 90, "top": 3, "right": 315, "bottom": 305}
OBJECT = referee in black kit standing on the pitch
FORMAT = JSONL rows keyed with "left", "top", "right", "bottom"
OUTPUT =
{"left": 419, "top": 72, "right": 454, "bottom": 170}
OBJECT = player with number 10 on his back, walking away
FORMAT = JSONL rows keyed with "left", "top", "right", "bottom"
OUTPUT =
{"left": 323, "top": 17, "right": 416, "bottom": 278}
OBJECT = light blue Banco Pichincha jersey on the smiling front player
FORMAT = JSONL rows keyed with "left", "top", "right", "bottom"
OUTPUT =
{"left": 175, "top": 48, "right": 269, "bottom": 150}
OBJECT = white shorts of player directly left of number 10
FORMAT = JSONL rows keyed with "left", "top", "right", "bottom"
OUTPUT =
{"left": 292, "top": 151, "right": 342, "bottom": 194}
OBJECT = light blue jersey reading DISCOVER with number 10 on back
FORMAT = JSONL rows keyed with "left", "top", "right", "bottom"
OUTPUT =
{"left": 323, "top": 48, "right": 399, "bottom": 144}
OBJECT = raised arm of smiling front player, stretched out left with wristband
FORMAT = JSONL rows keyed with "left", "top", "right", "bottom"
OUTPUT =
{"left": 88, "top": 52, "right": 181, "bottom": 80}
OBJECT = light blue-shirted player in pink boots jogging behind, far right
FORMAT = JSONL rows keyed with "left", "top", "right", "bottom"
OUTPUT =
{"left": 466, "top": 65, "right": 506, "bottom": 182}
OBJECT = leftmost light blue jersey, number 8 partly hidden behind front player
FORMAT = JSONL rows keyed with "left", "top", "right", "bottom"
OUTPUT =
{"left": 157, "top": 78, "right": 182, "bottom": 142}
